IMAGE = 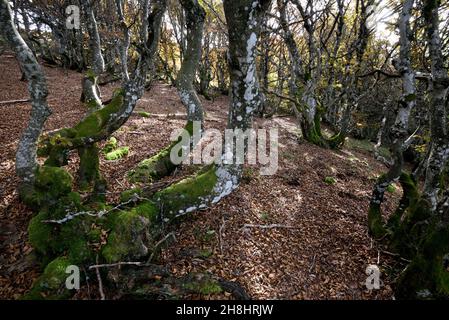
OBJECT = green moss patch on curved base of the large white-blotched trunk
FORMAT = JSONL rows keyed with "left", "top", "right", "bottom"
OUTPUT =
{"left": 155, "top": 167, "right": 217, "bottom": 219}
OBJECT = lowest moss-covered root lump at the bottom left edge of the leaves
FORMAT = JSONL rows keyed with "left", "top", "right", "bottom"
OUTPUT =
{"left": 22, "top": 257, "right": 74, "bottom": 300}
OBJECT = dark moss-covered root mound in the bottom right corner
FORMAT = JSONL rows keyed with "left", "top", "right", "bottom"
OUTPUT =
{"left": 395, "top": 226, "right": 449, "bottom": 300}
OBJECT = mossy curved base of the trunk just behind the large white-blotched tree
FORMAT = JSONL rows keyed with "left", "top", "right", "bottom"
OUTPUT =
{"left": 129, "top": 122, "right": 194, "bottom": 183}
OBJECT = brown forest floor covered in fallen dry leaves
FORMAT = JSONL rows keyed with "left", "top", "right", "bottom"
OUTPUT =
{"left": 0, "top": 53, "right": 401, "bottom": 299}
